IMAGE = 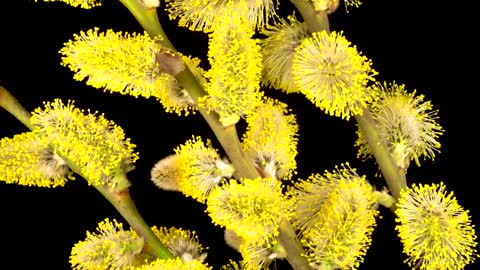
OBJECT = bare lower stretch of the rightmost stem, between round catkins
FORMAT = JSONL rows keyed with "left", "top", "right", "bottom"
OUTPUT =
{"left": 355, "top": 109, "right": 407, "bottom": 200}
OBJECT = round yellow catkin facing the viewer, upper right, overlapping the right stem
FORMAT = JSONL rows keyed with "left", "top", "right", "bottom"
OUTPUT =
{"left": 292, "top": 31, "right": 378, "bottom": 120}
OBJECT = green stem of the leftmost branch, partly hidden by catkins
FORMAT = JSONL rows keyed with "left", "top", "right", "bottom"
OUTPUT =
{"left": 0, "top": 86, "right": 174, "bottom": 259}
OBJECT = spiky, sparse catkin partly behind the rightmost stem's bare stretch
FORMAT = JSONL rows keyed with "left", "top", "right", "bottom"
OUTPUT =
{"left": 356, "top": 83, "right": 443, "bottom": 171}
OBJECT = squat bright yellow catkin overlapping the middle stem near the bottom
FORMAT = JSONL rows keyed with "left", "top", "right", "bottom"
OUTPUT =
{"left": 207, "top": 178, "right": 292, "bottom": 245}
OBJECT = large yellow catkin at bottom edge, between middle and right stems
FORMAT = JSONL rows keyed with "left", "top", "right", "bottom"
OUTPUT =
{"left": 290, "top": 164, "right": 378, "bottom": 269}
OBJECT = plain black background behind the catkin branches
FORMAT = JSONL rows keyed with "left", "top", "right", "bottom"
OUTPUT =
{"left": 0, "top": 0, "right": 480, "bottom": 270}
